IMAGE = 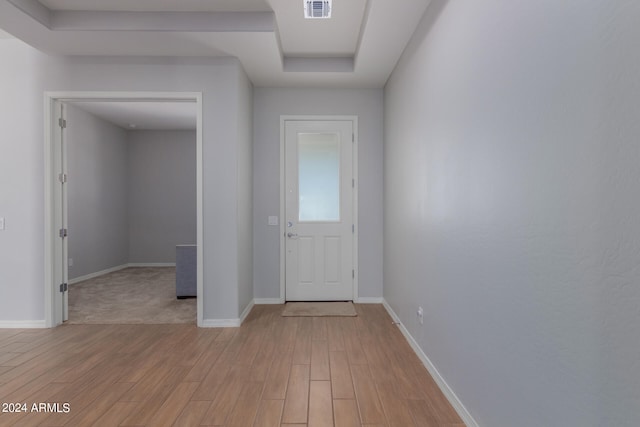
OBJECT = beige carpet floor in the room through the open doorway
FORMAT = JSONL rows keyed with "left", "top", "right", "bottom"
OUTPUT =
{"left": 67, "top": 267, "right": 196, "bottom": 324}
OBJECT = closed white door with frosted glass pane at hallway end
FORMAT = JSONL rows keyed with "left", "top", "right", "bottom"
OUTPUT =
{"left": 284, "top": 120, "right": 354, "bottom": 301}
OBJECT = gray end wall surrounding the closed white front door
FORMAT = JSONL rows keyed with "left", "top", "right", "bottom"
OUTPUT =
{"left": 253, "top": 88, "right": 383, "bottom": 298}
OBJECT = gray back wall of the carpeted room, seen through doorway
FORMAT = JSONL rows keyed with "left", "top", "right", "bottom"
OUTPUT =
{"left": 127, "top": 131, "right": 196, "bottom": 264}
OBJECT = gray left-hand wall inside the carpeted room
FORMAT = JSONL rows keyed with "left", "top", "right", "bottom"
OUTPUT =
{"left": 65, "top": 104, "right": 129, "bottom": 279}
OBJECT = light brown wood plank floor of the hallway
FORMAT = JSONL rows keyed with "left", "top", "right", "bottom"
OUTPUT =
{"left": 0, "top": 305, "right": 463, "bottom": 427}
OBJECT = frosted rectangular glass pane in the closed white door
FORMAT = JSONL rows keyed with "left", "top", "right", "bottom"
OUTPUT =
{"left": 298, "top": 133, "right": 340, "bottom": 222}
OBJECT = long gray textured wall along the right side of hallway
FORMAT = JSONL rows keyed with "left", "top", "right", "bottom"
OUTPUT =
{"left": 384, "top": 0, "right": 640, "bottom": 427}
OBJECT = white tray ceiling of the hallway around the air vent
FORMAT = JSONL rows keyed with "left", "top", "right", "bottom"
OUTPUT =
{"left": 0, "top": 0, "right": 430, "bottom": 88}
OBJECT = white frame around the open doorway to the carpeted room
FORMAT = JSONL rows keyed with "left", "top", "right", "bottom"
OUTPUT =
{"left": 44, "top": 92, "right": 204, "bottom": 328}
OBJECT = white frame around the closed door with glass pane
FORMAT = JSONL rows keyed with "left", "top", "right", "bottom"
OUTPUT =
{"left": 280, "top": 115, "right": 359, "bottom": 304}
